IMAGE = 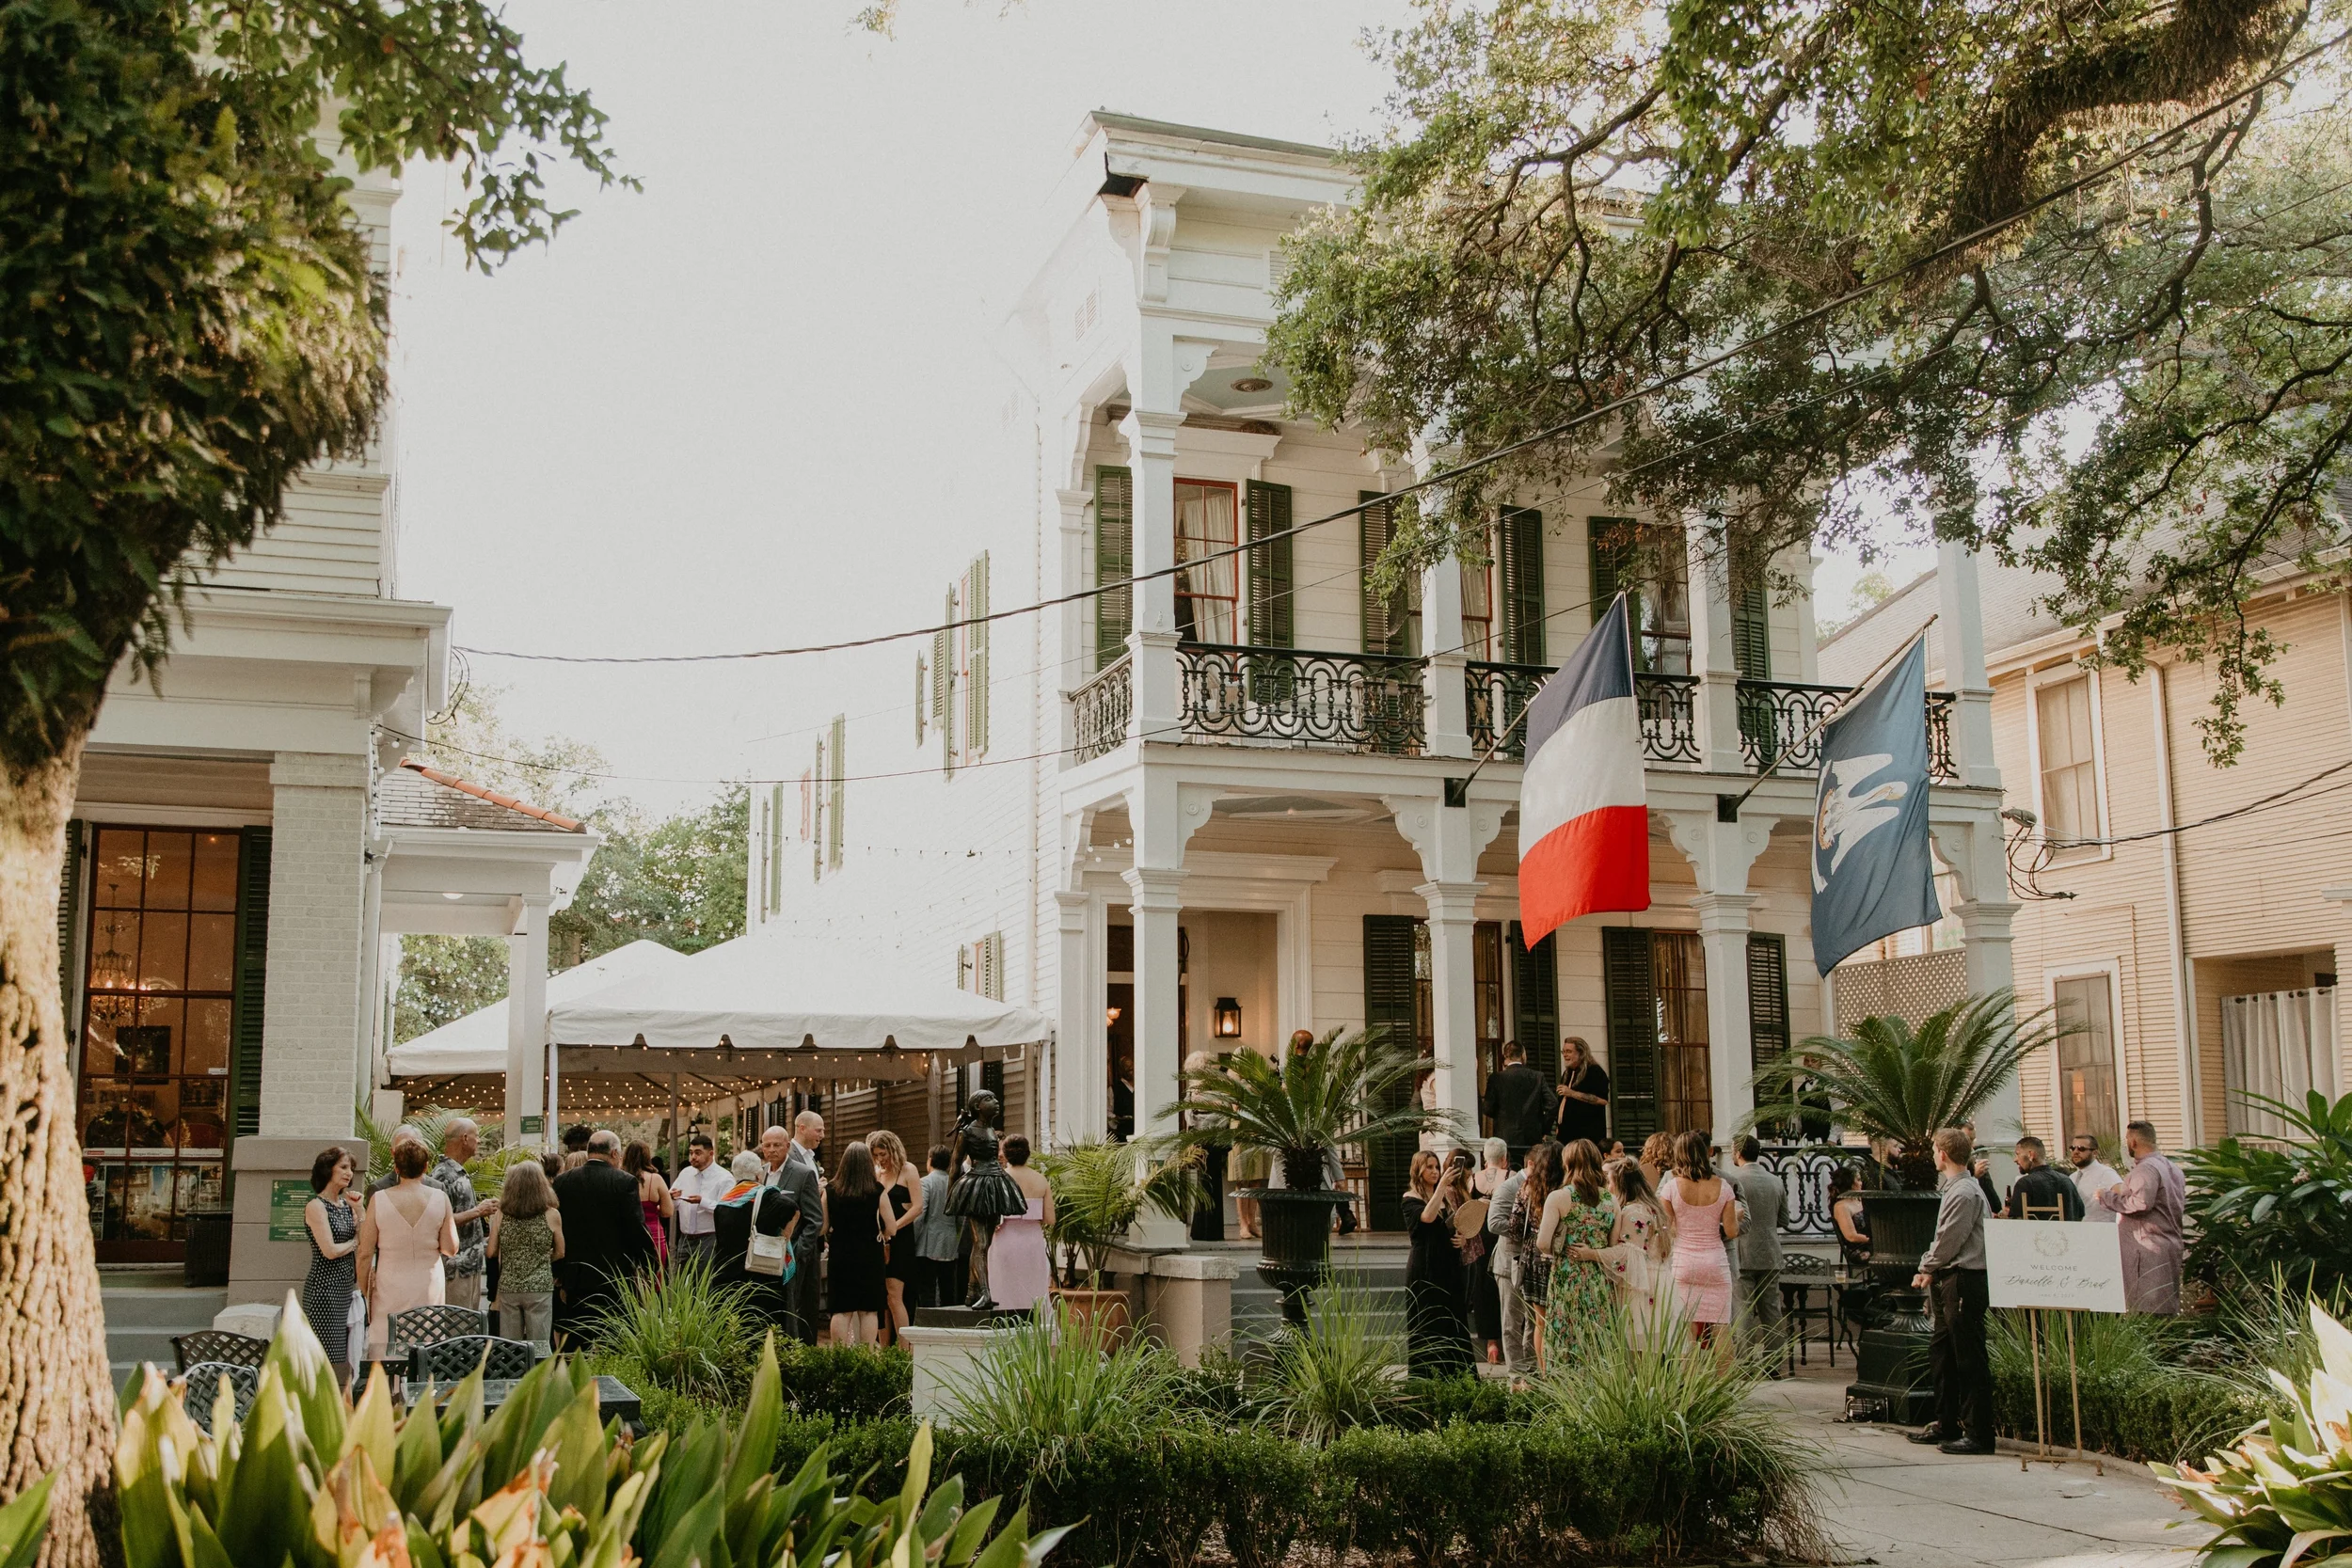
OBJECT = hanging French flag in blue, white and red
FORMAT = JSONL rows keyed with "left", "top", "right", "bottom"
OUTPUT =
{"left": 1519, "top": 594, "right": 1649, "bottom": 942}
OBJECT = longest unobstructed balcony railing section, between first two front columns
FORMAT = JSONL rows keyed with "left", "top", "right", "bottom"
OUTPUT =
{"left": 1176, "top": 641, "right": 1428, "bottom": 757}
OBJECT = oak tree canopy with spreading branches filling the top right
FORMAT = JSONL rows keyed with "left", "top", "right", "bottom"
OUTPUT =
{"left": 1270, "top": 0, "right": 2352, "bottom": 759}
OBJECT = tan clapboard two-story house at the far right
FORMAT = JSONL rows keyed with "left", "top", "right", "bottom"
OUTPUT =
{"left": 1820, "top": 533, "right": 2352, "bottom": 1159}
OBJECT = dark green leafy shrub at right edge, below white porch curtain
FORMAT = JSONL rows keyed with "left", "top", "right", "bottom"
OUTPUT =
{"left": 2181, "top": 1088, "right": 2352, "bottom": 1293}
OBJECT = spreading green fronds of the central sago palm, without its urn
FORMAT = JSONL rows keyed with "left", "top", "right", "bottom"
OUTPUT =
{"left": 1162, "top": 1027, "right": 1463, "bottom": 1192}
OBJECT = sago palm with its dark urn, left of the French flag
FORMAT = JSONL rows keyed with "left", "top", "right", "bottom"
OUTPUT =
{"left": 1169, "top": 1027, "right": 1456, "bottom": 1323}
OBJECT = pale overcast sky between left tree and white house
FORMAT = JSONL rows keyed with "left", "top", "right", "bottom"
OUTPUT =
{"left": 393, "top": 0, "right": 1919, "bottom": 809}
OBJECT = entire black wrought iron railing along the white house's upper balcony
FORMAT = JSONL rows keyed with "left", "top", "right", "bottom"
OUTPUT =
{"left": 1071, "top": 641, "right": 1957, "bottom": 781}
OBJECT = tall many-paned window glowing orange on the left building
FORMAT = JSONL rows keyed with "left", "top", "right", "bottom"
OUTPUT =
{"left": 80, "top": 828, "right": 240, "bottom": 1260}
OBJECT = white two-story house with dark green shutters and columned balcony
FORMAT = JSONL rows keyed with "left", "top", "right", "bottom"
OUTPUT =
{"left": 751, "top": 113, "right": 2011, "bottom": 1220}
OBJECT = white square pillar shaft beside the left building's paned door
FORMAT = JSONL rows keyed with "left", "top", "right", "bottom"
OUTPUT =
{"left": 262, "top": 752, "right": 367, "bottom": 1138}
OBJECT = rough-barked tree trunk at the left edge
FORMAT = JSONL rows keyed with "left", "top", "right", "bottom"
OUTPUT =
{"left": 0, "top": 736, "right": 122, "bottom": 1568}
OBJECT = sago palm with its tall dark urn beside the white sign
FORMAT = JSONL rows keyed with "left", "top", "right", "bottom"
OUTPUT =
{"left": 1750, "top": 990, "right": 2060, "bottom": 1422}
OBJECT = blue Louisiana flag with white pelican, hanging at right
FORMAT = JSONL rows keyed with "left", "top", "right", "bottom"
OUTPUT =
{"left": 1814, "top": 637, "right": 1941, "bottom": 974}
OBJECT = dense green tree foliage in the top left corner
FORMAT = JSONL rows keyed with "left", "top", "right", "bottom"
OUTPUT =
{"left": 0, "top": 0, "right": 626, "bottom": 768}
